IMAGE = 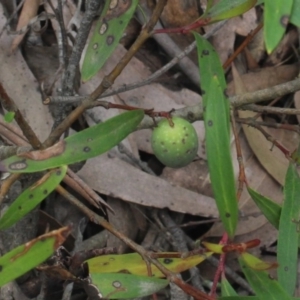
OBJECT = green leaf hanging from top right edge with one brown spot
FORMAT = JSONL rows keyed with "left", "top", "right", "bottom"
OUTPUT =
{"left": 264, "top": 0, "right": 294, "bottom": 53}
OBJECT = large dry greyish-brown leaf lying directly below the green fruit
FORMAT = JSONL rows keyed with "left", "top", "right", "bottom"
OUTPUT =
{"left": 77, "top": 154, "right": 218, "bottom": 217}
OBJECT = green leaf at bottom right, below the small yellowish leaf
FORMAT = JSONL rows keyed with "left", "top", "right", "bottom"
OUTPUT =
{"left": 239, "top": 256, "right": 292, "bottom": 300}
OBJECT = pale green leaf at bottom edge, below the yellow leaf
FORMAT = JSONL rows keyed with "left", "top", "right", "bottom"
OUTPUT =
{"left": 90, "top": 273, "right": 169, "bottom": 299}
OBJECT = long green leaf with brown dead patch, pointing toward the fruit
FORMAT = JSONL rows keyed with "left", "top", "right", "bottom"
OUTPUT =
{"left": 0, "top": 110, "right": 144, "bottom": 173}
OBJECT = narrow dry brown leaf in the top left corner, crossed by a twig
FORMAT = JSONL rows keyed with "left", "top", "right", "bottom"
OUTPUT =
{"left": 10, "top": 0, "right": 40, "bottom": 52}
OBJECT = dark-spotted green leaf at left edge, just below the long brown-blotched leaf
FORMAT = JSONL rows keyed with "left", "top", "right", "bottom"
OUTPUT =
{"left": 0, "top": 166, "right": 67, "bottom": 229}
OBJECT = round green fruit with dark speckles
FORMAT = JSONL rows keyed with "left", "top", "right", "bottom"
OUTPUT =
{"left": 151, "top": 117, "right": 198, "bottom": 168}
